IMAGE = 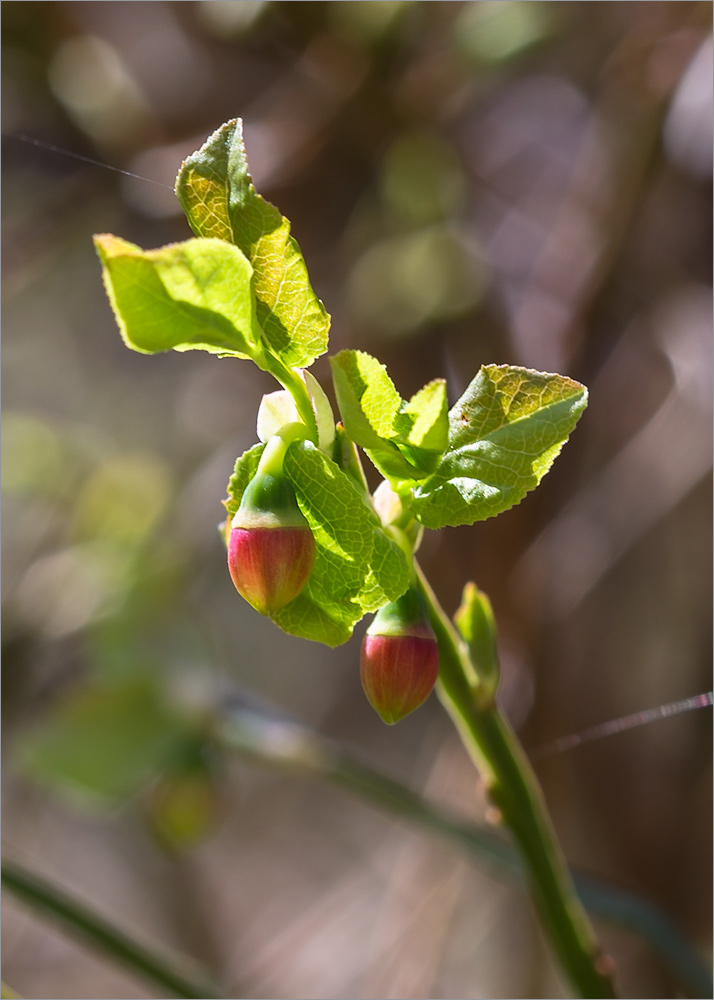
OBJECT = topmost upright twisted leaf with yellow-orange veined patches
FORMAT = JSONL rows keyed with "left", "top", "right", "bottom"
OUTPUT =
{"left": 176, "top": 118, "right": 330, "bottom": 368}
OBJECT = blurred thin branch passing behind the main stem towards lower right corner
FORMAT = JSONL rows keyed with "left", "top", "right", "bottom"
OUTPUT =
{"left": 214, "top": 702, "right": 712, "bottom": 998}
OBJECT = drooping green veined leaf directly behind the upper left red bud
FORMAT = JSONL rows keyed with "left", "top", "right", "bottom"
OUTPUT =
{"left": 226, "top": 442, "right": 409, "bottom": 646}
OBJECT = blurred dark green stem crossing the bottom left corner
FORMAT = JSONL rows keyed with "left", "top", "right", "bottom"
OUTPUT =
{"left": 2, "top": 862, "right": 224, "bottom": 1000}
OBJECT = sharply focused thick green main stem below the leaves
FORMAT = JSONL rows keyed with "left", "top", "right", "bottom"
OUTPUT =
{"left": 417, "top": 567, "right": 616, "bottom": 1000}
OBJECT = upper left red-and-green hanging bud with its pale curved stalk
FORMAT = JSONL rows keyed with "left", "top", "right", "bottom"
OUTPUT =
{"left": 228, "top": 438, "right": 315, "bottom": 617}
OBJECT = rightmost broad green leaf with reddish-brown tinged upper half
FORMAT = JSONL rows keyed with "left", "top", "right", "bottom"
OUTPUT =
{"left": 412, "top": 365, "right": 587, "bottom": 528}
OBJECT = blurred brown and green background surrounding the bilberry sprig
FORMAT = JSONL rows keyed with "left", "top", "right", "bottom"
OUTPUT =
{"left": 2, "top": 0, "right": 712, "bottom": 998}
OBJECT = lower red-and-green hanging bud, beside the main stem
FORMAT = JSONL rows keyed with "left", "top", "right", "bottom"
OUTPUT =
{"left": 361, "top": 588, "right": 439, "bottom": 725}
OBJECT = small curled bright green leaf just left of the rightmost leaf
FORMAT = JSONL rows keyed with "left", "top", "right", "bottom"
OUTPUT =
{"left": 331, "top": 351, "right": 448, "bottom": 482}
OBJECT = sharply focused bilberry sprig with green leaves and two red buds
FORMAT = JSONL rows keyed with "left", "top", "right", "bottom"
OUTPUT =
{"left": 95, "top": 119, "right": 614, "bottom": 997}
